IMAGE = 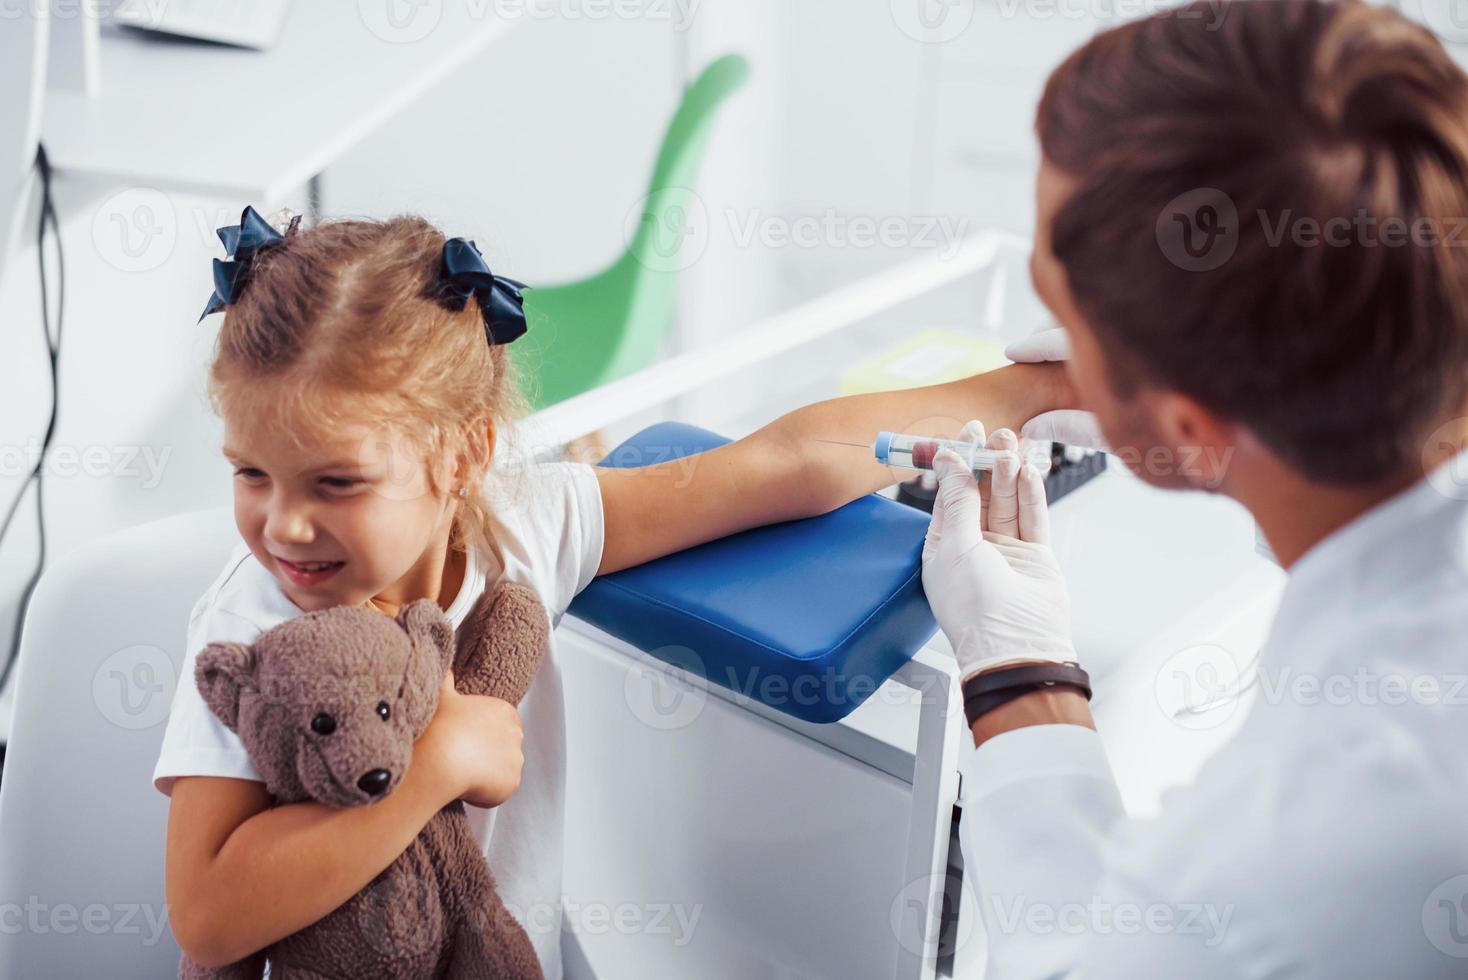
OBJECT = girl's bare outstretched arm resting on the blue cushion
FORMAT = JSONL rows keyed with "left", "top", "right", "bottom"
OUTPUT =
{"left": 596, "top": 364, "right": 1073, "bottom": 574}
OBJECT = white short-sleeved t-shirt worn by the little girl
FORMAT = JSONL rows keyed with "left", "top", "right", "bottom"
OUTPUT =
{"left": 153, "top": 462, "right": 603, "bottom": 980}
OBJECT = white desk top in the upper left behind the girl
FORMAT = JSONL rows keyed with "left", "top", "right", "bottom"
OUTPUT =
{"left": 41, "top": 0, "right": 517, "bottom": 202}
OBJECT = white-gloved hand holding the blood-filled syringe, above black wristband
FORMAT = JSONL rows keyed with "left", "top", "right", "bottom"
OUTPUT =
{"left": 922, "top": 423, "right": 1076, "bottom": 681}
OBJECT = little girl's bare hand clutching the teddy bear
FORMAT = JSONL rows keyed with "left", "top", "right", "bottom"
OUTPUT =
{"left": 420, "top": 670, "right": 526, "bottom": 807}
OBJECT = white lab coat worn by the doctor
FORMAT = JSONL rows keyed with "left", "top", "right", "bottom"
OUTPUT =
{"left": 960, "top": 453, "right": 1468, "bottom": 980}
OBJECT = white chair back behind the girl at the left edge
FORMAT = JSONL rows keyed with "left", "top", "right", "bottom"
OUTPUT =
{"left": 0, "top": 508, "right": 239, "bottom": 980}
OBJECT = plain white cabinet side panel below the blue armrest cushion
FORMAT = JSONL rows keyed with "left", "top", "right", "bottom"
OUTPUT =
{"left": 556, "top": 616, "right": 912, "bottom": 980}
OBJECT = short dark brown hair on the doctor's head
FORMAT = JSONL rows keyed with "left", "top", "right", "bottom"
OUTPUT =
{"left": 1036, "top": 0, "right": 1468, "bottom": 484}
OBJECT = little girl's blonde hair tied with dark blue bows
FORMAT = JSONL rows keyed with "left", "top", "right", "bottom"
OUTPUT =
{"left": 208, "top": 216, "right": 524, "bottom": 550}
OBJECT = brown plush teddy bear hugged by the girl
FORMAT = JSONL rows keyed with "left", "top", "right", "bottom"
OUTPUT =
{"left": 179, "top": 584, "right": 549, "bottom": 980}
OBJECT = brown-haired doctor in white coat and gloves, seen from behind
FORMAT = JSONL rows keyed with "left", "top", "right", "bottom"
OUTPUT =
{"left": 923, "top": 0, "right": 1468, "bottom": 980}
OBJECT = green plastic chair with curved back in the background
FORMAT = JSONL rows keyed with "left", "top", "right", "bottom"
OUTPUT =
{"left": 515, "top": 54, "right": 749, "bottom": 409}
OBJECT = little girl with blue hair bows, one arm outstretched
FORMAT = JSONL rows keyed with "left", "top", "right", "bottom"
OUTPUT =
{"left": 153, "top": 208, "right": 1069, "bottom": 980}
